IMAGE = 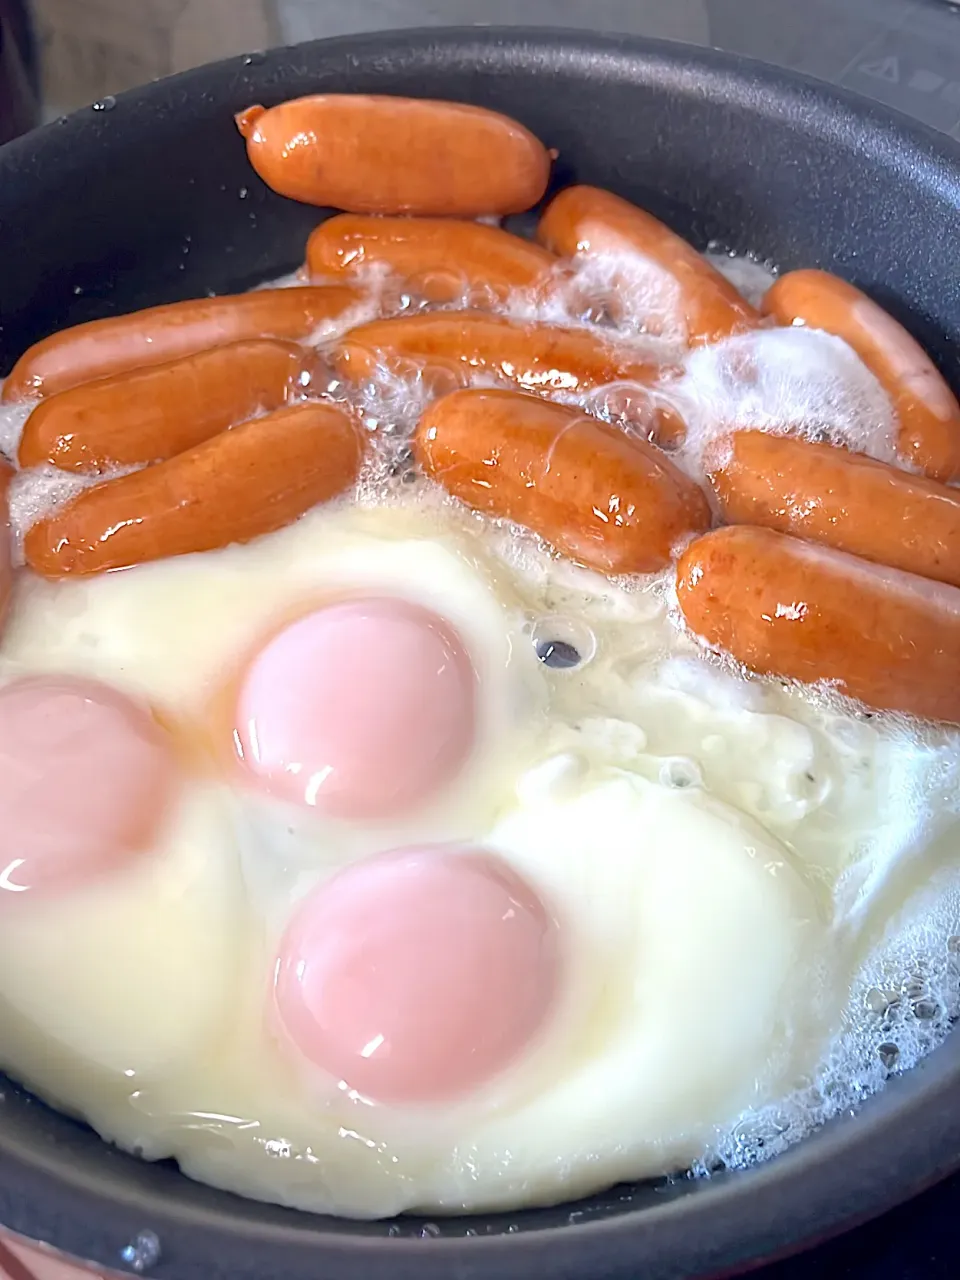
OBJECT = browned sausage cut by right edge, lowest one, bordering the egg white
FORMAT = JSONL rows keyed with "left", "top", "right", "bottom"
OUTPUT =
{"left": 677, "top": 525, "right": 960, "bottom": 723}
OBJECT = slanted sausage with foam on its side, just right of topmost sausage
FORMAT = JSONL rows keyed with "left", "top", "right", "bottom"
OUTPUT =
{"left": 536, "top": 187, "right": 760, "bottom": 347}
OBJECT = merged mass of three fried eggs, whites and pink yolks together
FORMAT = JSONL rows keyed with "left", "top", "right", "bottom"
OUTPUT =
{"left": 0, "top": 465, "right": 956, "bottom": 1217}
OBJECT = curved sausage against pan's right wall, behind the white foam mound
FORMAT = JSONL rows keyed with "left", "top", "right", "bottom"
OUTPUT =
{"left": 762, "top": 271, "right": 960, "bottom": 483}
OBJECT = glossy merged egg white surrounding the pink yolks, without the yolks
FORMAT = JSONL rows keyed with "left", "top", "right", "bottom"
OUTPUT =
{"left": 0, "top": 494, "right": 952, "bottom": 1217}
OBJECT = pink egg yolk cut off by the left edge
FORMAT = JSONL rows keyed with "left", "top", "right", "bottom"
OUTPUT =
{"left": 0, "top": 676, "right": 177, "bottom": 892}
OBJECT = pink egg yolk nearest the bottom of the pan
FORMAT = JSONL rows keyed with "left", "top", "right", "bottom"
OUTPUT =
{"left": 274, "top": 846, "right": 559, "bottom": 1103}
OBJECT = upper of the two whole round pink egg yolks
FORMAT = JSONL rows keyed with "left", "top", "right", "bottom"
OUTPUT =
{"left": 234, "top": 599, "right": 476, "bottom": 819}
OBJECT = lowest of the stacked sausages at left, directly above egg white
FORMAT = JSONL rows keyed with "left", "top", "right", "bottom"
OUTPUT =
{"left": 24, "top": 401, "right": 364, "bottom": 577}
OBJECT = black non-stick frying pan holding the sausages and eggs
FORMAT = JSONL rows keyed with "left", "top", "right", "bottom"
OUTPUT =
{"left": 0, "top": 28, "right": 960, "bottom": 1280}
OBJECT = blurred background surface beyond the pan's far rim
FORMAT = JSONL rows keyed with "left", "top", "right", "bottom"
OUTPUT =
{"left": 0, "top": 0, "right": 960, "bottom": 141}
